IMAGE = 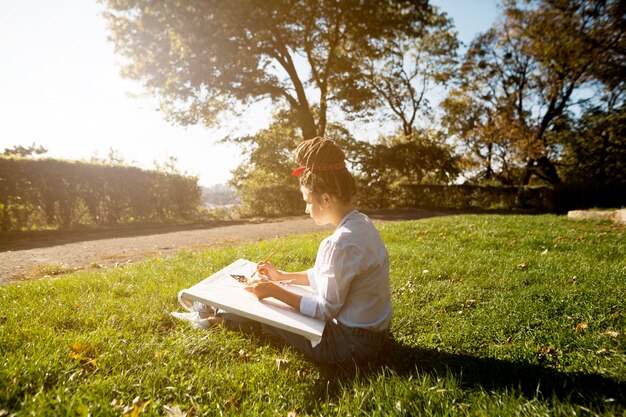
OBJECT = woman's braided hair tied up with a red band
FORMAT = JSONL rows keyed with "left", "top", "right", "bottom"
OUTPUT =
{"left": 296, "top": 136, "right": 356, "bottom": 202}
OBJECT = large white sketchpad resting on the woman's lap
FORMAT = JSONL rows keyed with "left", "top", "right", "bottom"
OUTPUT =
{"left": 178, "top": 259, "right": 324, "bottom": 346}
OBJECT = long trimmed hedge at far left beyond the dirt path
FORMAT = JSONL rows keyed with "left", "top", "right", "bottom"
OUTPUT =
{"left": 0, "top": 158, "right": 200, "bottom": 231}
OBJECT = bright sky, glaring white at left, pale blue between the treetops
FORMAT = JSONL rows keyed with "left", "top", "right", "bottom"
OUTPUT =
{"left": 0, "top": 0, "right": 497, "bottom": 186}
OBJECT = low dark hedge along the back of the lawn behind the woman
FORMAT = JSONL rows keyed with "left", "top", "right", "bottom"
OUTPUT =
{"left": 230, "top": 183, "right": 626, "bottom": 217}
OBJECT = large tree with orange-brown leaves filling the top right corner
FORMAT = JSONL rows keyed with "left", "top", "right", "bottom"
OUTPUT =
{"left": 448, "top": 0, "right": 626, "bottom": 184}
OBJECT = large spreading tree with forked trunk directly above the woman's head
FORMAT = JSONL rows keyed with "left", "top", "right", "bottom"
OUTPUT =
{"left": 101, "top": 0, "right": 429, "bottom": 138}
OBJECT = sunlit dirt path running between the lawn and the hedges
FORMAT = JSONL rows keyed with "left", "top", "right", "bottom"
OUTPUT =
{"left": 0, "top": 210, "right": 450, "bottom": 284}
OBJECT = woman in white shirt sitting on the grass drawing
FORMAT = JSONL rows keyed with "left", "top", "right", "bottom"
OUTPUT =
{"left": 238, "top": 137, "right": 392, "bottom": 365}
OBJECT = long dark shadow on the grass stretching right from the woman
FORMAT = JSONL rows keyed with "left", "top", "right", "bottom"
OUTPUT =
{"left": 314, "top": 338, "right": 626, "bottom": 410}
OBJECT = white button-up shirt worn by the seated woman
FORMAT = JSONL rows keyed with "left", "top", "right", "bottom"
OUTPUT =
{"left": 300, "top": 210, "right": 393, "bottom": 331}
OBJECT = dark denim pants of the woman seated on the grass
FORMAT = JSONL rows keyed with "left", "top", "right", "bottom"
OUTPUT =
{"left": 218, "top": 311, "right": 389, "bottom": 366}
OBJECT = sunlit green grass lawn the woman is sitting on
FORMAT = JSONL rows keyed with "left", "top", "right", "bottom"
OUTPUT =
{"left": 0, "top": 215, "right": 626, "bottom": 416}
